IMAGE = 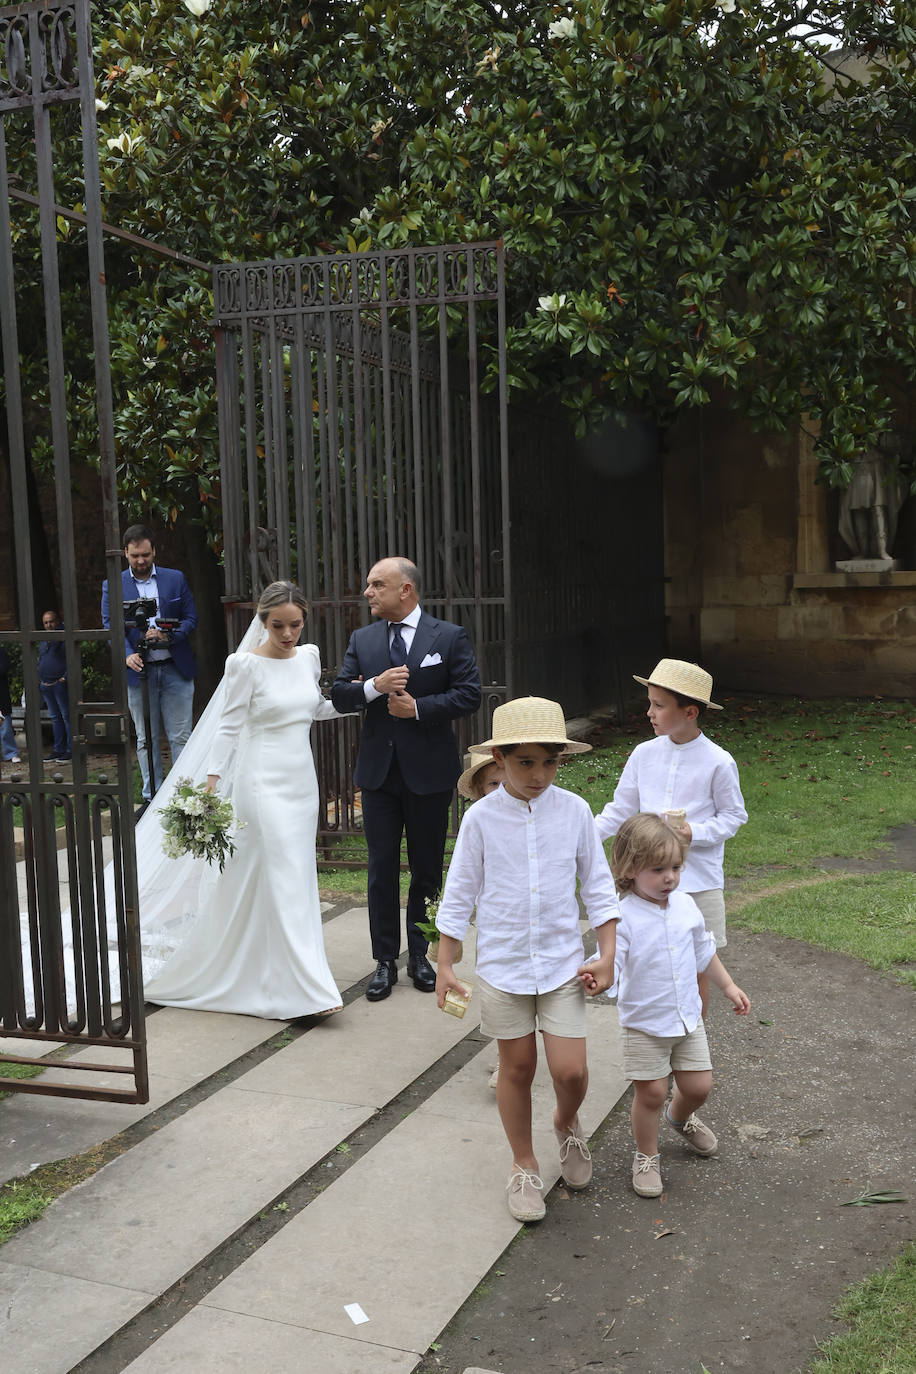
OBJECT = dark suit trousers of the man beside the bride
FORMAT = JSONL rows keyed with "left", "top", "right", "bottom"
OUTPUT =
{"left": 363, "top": 758, "right": 453, "bottom": 959}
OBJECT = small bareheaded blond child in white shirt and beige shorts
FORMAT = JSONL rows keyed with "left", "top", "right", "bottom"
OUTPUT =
{"left": 611, "top": 813, "right": 750, "bottom": 1198}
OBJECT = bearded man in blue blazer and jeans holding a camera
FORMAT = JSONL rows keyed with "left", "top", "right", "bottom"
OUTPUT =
{"left": 102, "top": 525, "right": 198, "bottom": 801}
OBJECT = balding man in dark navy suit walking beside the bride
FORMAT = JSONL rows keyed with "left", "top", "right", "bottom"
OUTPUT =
{"left": 331, "top": 558, "right": 481, "bottom": 1002}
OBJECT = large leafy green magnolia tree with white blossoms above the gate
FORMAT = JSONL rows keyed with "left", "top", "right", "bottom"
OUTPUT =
{"left": 8, "top": 0, "right": 916, "bottom": 528}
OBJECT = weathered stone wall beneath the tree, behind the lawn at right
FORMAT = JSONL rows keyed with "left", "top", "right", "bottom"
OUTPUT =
{"left": 665, "top": 414, "right": 916, "bottom": 697}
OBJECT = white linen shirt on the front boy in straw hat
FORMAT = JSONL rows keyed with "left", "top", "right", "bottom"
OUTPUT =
{"left": 435, "top": 785, "right": 619, "bottom": 993}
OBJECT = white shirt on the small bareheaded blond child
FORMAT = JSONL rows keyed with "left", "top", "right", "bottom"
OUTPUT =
{"left": 611, "top": 892, "right": 715, "bottom": 1036}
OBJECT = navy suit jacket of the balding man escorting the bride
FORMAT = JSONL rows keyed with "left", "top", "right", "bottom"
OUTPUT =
{"left": 331, "top": 611, "right": 481, "bottom": 796}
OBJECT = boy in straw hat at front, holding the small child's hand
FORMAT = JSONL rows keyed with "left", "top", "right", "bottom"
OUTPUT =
{"left": 435, "top": 697, "right": 619, "bottom": 1221}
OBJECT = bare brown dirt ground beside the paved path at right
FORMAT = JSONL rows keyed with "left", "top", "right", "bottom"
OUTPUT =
{"left": 419, "top": 827, "right": 916, "bottom": 1374}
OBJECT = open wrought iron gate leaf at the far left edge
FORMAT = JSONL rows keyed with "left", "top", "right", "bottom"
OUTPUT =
{"left": 0, "top": 0, "right": 148, "bottom": 1102}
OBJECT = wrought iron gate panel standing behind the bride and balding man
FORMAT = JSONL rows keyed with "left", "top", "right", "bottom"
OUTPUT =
{"left": 214, "top": 243, "right": 511, "bottom": 837}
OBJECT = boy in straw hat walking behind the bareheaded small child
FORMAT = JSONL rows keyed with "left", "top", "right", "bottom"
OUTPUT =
{"left": 597, "top": 658, "right": 747, "bottom": 1015}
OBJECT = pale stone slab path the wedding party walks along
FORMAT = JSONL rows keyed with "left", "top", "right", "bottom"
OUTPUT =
{"left": 0, "top": 904, "right": 626, "bottom": 1374}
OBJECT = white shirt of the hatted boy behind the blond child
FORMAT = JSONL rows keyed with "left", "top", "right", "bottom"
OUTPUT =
{"left": 596, "top": 734, "right": 747, "bottom": 892}
